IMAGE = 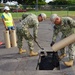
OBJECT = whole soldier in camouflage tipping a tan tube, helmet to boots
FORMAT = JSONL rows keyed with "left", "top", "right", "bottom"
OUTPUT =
{"left": 50, "top": 14, "right": 75, "bottom": 66}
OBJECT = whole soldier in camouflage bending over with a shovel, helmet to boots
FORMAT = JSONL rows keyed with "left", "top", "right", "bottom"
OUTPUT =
{"left": 16, "top": 13, "right": 46, "bottom": 56}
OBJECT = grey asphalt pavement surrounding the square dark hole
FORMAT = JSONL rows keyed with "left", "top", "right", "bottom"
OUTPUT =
{"left": 0, "top": 19, "right": 75, "bottom": 75}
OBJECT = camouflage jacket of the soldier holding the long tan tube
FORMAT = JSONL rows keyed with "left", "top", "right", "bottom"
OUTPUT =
{"left": 52, "top": 17, "right": 75, "bottom": 42}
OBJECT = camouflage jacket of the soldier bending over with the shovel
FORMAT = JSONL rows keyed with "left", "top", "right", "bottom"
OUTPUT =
{"left": 17, "top": 13, "right": 39, "bottom": 37}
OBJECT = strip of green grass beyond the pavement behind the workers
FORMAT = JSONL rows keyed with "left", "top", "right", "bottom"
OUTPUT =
{"left": 0, "top": 11, "right": 75, "bottom": 19}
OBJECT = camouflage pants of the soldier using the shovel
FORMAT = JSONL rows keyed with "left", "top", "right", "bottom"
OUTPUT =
{"left": 16, "top": 28, "right": 34, "bottom": 50}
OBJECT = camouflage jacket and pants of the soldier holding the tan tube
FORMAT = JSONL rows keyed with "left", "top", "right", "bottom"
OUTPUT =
{"left": 52, "top": 17, "right": 75, "bottom": 59}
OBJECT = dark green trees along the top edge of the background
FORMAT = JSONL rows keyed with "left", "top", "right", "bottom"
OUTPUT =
{"left": 0, "top": 0, "right": 75, "bottom": 5}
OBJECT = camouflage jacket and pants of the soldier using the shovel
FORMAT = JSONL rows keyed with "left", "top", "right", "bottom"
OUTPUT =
{"left": 16, "top": 14, "right": 39, "bottom": 50}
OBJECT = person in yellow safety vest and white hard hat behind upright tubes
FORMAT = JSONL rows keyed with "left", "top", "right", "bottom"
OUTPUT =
{"left": 1, "top": 6, "right": 14, "bottom": 30}
